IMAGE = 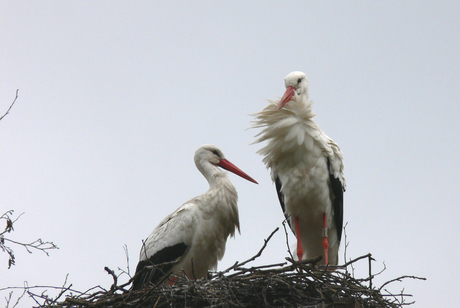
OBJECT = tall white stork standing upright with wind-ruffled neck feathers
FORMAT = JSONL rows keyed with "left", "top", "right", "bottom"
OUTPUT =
{"left": 253, "top": 72, "right": 345, "bottom": 265}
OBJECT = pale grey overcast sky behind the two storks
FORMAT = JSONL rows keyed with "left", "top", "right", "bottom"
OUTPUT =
{"left": 0, "top": 1, "right": 460, "bottom": 307}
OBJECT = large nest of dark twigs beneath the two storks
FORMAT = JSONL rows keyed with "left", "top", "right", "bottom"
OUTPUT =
{"left": 28, "top": 228, "right": 425, "bottom": 308}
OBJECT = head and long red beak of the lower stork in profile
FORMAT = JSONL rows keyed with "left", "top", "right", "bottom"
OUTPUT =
{"left": 195, "top": 144, "right": 258, "bottom": 184}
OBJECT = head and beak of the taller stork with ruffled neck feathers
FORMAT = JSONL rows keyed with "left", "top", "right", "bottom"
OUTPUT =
{"left": 278, "top": 71, "right": 308, "bottom": 110}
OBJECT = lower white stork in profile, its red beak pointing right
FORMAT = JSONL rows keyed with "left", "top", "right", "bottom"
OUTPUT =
{"left": 132, "top": 144, "right": 257, "bottom": 290}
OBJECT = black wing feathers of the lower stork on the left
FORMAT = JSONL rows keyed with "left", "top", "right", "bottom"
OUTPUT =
{"left": 132, "top": 243, "right": 188, "bottom": 290}
